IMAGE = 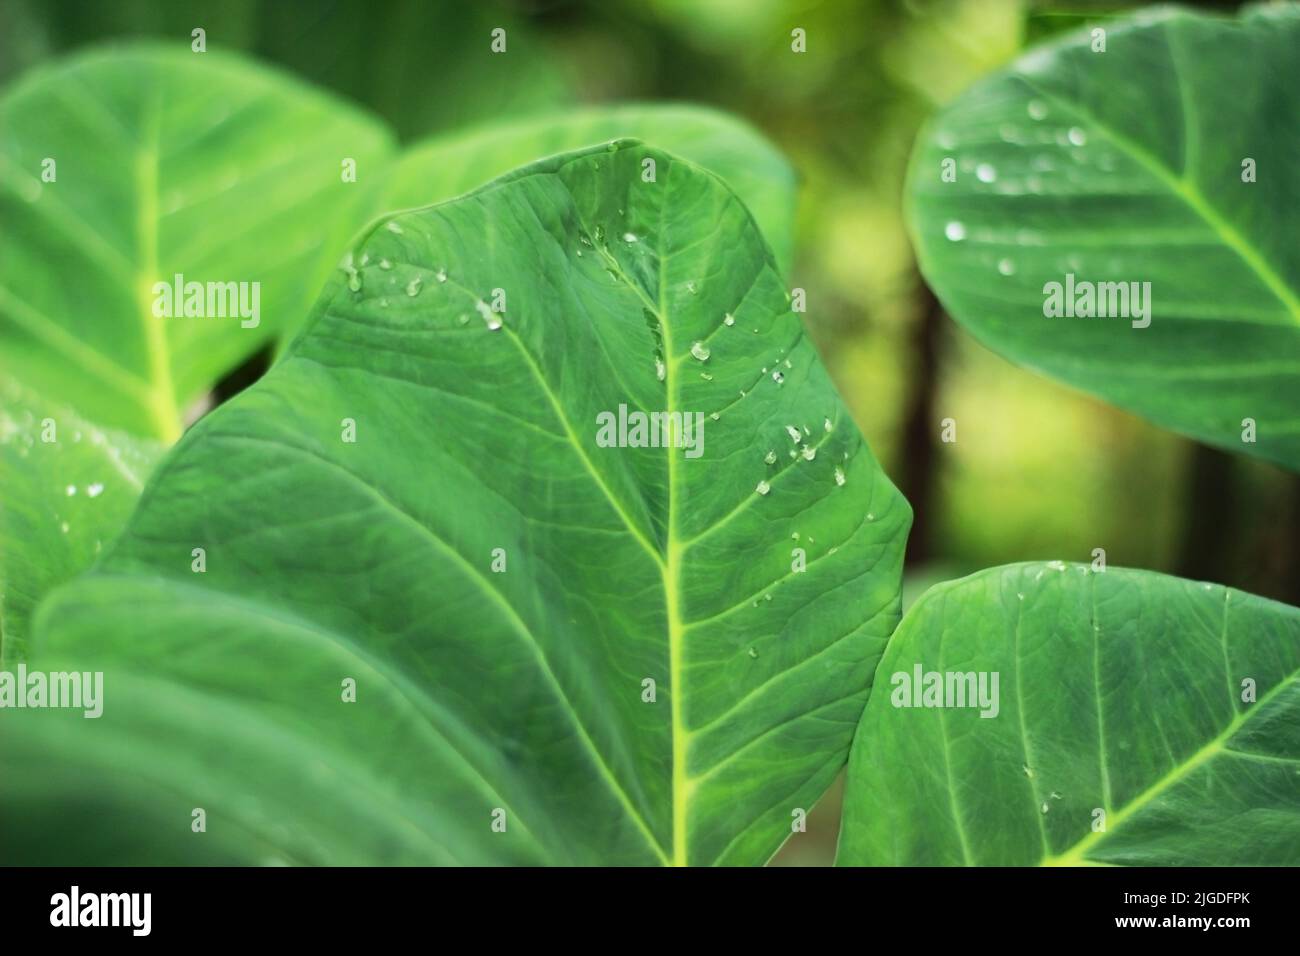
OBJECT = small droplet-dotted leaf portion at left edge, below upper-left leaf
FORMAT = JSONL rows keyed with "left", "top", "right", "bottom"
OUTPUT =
{"left": 0, "top": 376, "right": 161, "bottom": 665}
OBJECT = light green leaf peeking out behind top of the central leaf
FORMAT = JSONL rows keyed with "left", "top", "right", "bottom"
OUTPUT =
{"left": 381, "top": 103, "right": 794, "bottom": 274}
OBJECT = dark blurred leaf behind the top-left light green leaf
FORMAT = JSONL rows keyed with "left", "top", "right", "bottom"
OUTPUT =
{"left": 0, "top": 0, "right": 571, "bottom": 138}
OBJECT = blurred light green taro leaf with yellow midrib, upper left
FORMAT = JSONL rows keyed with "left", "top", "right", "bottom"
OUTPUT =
{"left": 0, "top": 46, "right": 389, "bottom": 440}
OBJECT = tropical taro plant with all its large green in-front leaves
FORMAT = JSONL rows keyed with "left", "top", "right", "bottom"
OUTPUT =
{"left": 0, "top": 7, "right": 1300, "bottom": 865}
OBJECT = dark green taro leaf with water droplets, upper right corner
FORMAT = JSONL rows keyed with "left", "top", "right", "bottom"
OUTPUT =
{"left": 910, "top": 5, "right": 1300, "bottom": 468}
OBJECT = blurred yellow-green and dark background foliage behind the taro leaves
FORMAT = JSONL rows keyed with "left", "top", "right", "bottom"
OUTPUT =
{"left": 0, "top": 0, "right": 1300, "bottom": 864}
